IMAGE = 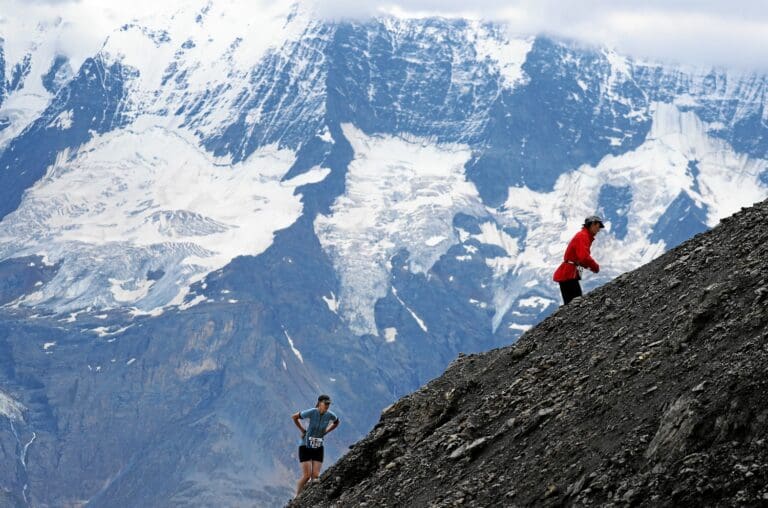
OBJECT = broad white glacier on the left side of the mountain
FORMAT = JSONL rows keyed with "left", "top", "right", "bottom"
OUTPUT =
{"left": 0, "top": 116, "right": 316, "bottom": 312}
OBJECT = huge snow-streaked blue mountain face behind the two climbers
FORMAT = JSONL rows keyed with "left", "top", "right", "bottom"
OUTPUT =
{"left": 0, "top": 1, "right": 768, "bottom": 506}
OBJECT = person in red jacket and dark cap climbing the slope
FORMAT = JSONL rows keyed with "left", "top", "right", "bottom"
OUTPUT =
{"left": 552, "top": 215, "right": 605, "bottom": 304}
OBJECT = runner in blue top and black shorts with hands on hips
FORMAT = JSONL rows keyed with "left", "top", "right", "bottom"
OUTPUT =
{"left": 291, "top": 395, "right": 341, "bottom": 496}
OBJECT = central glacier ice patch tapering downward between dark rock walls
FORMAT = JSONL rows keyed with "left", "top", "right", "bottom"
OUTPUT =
{"left": 315, "top": 124, "right": 482, "bottom": 334}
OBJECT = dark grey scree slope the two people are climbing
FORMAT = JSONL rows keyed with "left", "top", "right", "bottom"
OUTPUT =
{"left": 292, "top": 198, "right": 768, "bottom": 506}
